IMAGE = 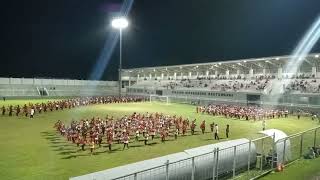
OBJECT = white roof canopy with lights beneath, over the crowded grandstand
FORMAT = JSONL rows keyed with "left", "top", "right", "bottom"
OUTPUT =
{"left": 123, "top": 53, "right": 320, "bottom": 77}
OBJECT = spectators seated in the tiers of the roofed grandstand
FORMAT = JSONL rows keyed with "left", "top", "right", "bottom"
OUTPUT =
{"left": 136, "top": 74, "right": 320, "bottom": 93}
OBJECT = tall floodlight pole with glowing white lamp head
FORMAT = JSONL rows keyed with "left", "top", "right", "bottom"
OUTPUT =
{"left": 111, "top": 17, "right": 129, "bottom": 97}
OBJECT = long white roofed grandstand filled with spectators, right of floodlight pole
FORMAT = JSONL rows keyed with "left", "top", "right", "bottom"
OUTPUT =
{"left": 122, "top": 53, "right": 320, "bottom": 108}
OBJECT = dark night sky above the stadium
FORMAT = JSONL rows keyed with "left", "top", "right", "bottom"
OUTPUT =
{"left": 0, "top": 0, "right": 320, "bottom": 80}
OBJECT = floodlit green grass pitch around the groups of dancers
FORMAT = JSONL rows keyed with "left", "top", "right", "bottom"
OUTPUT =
{"left": 0, "top": 99, "right": 320, "bottom": 180}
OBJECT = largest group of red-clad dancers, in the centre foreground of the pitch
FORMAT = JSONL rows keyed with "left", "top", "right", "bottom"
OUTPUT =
{"left": 54, "top": 113, "right": 229, "bottom": 153}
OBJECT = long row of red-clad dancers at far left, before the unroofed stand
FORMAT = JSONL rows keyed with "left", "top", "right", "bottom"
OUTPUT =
{"left": 1, "top": 96, "right": 145, "bottom": 118}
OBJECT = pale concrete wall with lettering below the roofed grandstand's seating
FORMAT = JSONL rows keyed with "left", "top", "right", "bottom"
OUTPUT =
{"left": 127, "top": 87, "right": 320, "bottom": 111}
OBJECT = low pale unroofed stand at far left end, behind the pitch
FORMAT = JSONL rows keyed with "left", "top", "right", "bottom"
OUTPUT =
{"left": 0, "top": 78, "right": 118, "bottom": 98}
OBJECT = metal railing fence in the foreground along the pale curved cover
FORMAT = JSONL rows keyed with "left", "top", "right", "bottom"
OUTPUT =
{"left": 112, "top": 127, "right": 320, "bottom": 180}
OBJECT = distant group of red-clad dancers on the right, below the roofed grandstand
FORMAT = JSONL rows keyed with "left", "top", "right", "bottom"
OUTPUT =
{"left": 196, "top": 104, "right": 289, "bottom": 121}
